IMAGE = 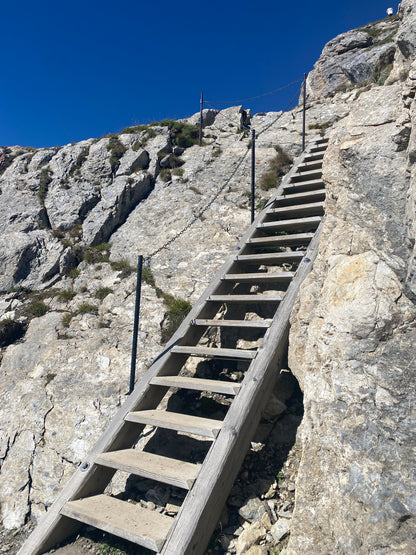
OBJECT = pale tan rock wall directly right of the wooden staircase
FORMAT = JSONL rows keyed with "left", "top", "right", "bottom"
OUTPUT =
{"left": 285, "top": 2, "right": 416, "bottom": 555}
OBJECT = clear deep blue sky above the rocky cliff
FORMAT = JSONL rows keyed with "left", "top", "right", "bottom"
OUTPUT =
{"left": 0, "top": 0, "right": 397, "bottom": 147}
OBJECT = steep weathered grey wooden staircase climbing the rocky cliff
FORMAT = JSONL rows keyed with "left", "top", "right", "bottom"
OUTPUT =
{"left": 19, "top": 138, "right": 327, "bottom": 555}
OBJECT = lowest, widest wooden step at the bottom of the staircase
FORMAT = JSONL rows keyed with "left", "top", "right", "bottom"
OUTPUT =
{"left": 61, "top": 495, "right": 173, "bottom": 551}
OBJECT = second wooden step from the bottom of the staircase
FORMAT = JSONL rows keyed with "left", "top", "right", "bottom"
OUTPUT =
{"left": 95, "top": 452, "right": 201, "bottom": 489}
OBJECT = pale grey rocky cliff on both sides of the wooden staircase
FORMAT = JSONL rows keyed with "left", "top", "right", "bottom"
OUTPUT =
{"left": 0, "top": 0, "right": 416, "bottom": 555}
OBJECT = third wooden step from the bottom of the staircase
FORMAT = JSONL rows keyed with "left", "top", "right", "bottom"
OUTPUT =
{"left": 125, "top": 410, "right": 222, "bottom": 439}
